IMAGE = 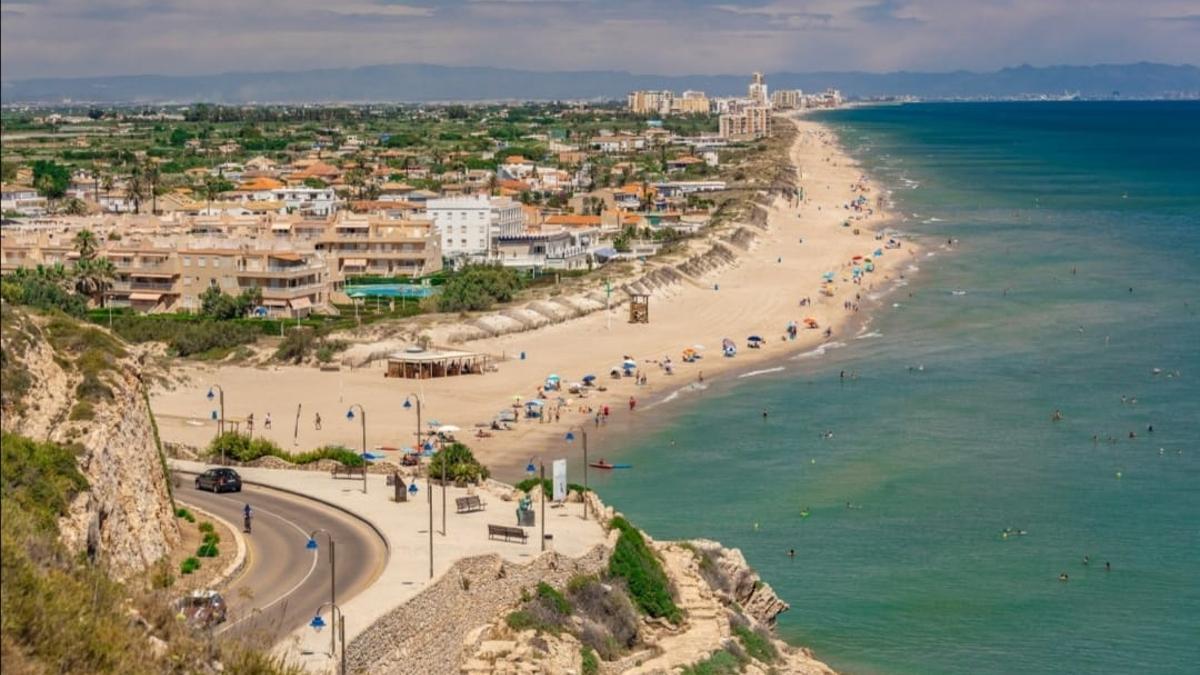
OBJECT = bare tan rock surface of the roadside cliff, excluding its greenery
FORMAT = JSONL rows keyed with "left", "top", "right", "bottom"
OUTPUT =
{"left": 2, "top": 309, "right": 179, "bottom": 580}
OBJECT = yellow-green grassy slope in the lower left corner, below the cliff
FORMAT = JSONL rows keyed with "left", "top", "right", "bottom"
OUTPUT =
{"left": 0, "top": 434, "right": 299, "bottom": 675}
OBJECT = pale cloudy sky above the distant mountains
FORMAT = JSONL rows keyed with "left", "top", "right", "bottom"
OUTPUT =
{"left": 0, "top": 0, "right": 1200, "bottom": 79}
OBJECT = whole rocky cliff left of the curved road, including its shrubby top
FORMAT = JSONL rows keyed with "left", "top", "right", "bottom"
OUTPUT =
{"left": 0, "top": 304, "right": 179, "bottom": 579}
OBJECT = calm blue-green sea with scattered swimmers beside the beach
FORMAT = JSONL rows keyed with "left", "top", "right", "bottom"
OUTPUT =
{"left": 593, "top": 102, "right": 1200, "bottom": 673}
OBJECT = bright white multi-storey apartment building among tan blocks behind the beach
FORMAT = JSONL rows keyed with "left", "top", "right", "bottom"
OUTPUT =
{"left": 425, "top": 195, "right": 524, "bottom": 258}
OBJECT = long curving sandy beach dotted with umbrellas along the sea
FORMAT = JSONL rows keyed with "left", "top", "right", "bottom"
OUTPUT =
{"left": 151, "top": 118, "right": 914, "bottom": 478}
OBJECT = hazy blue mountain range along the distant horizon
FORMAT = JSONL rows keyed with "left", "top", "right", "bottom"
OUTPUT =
{"left": 0, "top": 62, "right": 1200, "bottom": 103}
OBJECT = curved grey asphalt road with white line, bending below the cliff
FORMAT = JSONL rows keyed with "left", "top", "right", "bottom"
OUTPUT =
{"left": 175, "top": 473, "right": 388, "bottom": 645}
